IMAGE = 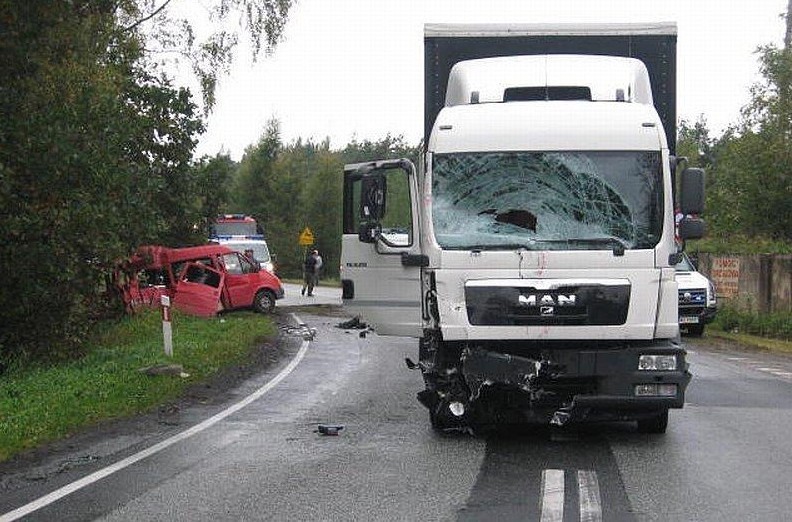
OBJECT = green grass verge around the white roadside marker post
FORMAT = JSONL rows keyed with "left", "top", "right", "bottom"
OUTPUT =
{"left": 0, "top": 310, "right": 276, "bottom": 462}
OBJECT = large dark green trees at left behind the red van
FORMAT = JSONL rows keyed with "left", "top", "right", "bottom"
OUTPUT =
{"left": 0, "top": 0, "right": 290, "bottom": 371}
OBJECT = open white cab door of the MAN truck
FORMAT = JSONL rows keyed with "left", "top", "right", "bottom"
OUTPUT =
{"left": 341, "top": 159, "right": 428, "bottom": 337}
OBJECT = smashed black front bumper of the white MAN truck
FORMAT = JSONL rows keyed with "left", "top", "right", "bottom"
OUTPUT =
{"left": 454, "top": 344, "right": 691, "bottom": 426}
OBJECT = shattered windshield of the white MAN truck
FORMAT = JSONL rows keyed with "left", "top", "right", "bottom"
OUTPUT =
{"left": 432, "top": 151, "right": 663, "bottom": 250}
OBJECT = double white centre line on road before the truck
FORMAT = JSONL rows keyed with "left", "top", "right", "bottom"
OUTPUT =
{"left": 541, "top": 469, "right": 602, "bottom": 522}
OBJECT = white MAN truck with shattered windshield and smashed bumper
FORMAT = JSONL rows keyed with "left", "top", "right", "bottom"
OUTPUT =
{"left": 341, "top": 23, "right": 705, "bottom": 432}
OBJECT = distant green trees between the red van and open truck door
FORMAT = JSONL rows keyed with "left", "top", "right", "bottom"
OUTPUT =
{"left": 226, "top": 133, "right": 419, "bottom": 277}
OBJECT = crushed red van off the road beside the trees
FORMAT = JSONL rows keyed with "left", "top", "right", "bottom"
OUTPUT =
{"left": 123, "top": 244, "right": 284, "bottom": 316}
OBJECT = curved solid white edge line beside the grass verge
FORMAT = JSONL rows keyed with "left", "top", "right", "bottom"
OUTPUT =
{"left": 0, "top": 314, "right": 310, "bottom": 522}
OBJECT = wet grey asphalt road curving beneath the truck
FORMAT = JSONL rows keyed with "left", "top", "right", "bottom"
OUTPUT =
{"left": 0, "top": 287, "right": 792, "bottom": 522}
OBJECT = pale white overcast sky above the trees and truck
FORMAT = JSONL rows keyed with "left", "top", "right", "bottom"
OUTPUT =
{"left": 182, "top": 0, "right": 787, "bottom": 160}
